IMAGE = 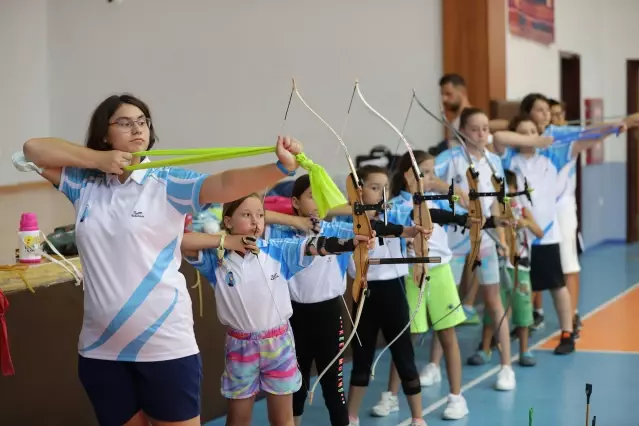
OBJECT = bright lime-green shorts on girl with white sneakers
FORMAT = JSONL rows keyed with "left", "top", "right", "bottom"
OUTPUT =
{"left": 405, "top": 264, "right": 466, "bottom": 334}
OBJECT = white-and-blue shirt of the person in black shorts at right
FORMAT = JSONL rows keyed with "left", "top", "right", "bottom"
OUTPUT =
{"left": 502, "top": 142, "right": 574, "bottom": 245}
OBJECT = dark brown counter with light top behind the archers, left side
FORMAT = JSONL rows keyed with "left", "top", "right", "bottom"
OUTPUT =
{"left": 0, "top": 258, "right": 357, "bottom": 426}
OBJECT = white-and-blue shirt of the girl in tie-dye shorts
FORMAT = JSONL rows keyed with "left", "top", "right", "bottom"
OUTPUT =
{"left": 187, "top": 238, "right": 313, "bottom": 333}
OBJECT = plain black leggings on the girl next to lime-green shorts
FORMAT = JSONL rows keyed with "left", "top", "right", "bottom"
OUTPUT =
{"left": 351, "top": 277, "right": 421, "bottom": 395}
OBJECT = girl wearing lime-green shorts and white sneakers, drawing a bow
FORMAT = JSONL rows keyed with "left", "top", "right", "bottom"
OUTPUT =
{"left": 373, "top": 150, "right": 476, "bottom": 420}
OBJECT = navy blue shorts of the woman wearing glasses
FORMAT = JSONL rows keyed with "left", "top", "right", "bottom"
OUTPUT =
{"left": 78, "top": 354, "right": 202, "bottom": 426}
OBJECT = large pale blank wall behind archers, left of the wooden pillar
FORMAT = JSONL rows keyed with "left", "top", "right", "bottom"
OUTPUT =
{"left": 40, "top": 0, "right": 442, "bottom": 177}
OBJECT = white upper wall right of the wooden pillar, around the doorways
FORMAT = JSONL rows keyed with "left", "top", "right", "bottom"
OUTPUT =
{"left": 505, "top": 0, "right": 639, "bottom": 162}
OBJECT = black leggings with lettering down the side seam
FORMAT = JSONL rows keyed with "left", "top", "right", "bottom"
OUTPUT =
{"left": 290, "top": 297, "right": 349, "bottom": 426}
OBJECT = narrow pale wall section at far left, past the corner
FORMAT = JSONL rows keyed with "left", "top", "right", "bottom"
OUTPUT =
{"left": 0, "top": 0, "right": 49, "bottom": 185}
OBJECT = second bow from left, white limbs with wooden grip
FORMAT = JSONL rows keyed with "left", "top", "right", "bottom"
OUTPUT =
{"left": 355, "top": 81, "right": 433, "bottom": 377}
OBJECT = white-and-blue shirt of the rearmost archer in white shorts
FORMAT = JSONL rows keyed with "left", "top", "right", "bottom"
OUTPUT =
{"left": 544, "top": 125, "right": 585, "bottom": 211}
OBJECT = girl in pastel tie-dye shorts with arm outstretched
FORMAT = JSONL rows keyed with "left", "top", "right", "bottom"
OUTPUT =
{"left": 182, "top": 194, "right": 375, "bottom": 424}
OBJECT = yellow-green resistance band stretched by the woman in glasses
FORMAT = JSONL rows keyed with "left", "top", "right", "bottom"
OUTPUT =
{"left": 124, "top": 146, "right": 347, "bottom": 219}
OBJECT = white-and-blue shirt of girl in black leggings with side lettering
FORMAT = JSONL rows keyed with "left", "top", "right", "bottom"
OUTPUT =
{"left": 265, "top": 221, "right": 354, "bottom": 303}
